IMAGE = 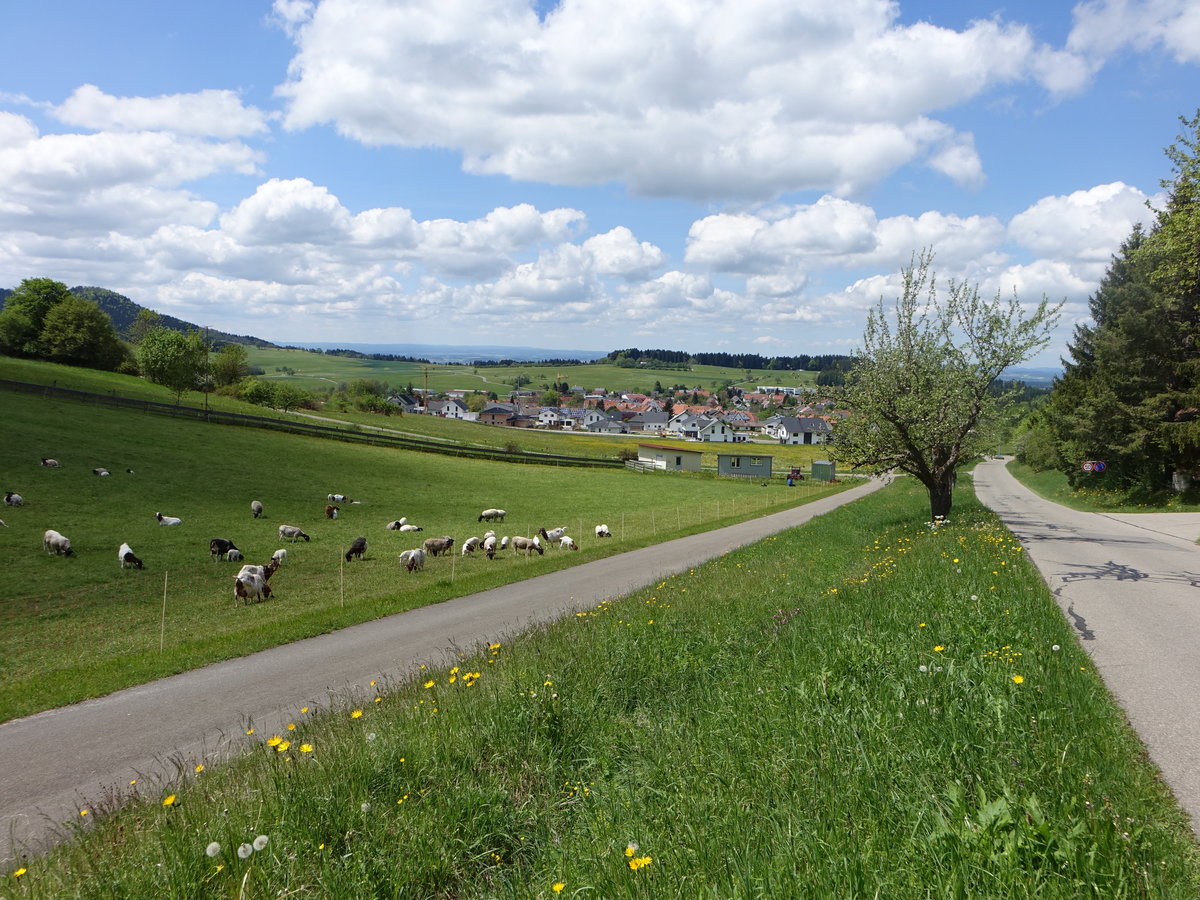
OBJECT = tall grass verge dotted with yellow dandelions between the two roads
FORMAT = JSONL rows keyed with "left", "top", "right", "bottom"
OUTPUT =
{"left": 0, "top": 479, "right": 1200, "bottom": 899}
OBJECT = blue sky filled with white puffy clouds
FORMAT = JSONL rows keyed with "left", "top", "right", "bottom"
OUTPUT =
{"left": 0, "top": 0, "right": 1200, "bottom": 365}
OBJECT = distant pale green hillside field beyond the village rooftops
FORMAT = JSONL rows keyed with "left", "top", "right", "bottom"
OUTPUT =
{"left": 248, "top": 347, "right": 817, "bottom": 394}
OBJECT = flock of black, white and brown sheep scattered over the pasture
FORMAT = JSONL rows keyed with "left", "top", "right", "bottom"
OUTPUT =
{"left": 16, "top": 468, "right": 612, "bottom": 605}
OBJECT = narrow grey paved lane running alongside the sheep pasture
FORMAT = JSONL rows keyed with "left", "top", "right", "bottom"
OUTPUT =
{"left": 0, "top": 482, "right": 880, "bottom": 864}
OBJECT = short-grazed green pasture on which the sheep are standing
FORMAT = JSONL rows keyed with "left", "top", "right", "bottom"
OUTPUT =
{"left": 0, "top": 392, "right": 846, "bottom": 721}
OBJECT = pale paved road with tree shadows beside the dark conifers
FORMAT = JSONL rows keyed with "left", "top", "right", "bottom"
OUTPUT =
{"left": 974, "top": 461, "right": 1200, "bottom": 836}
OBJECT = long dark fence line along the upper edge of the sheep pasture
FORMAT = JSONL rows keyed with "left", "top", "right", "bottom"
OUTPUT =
{"left": 0, "top": 379, "right": 624, "bottom": 468}
